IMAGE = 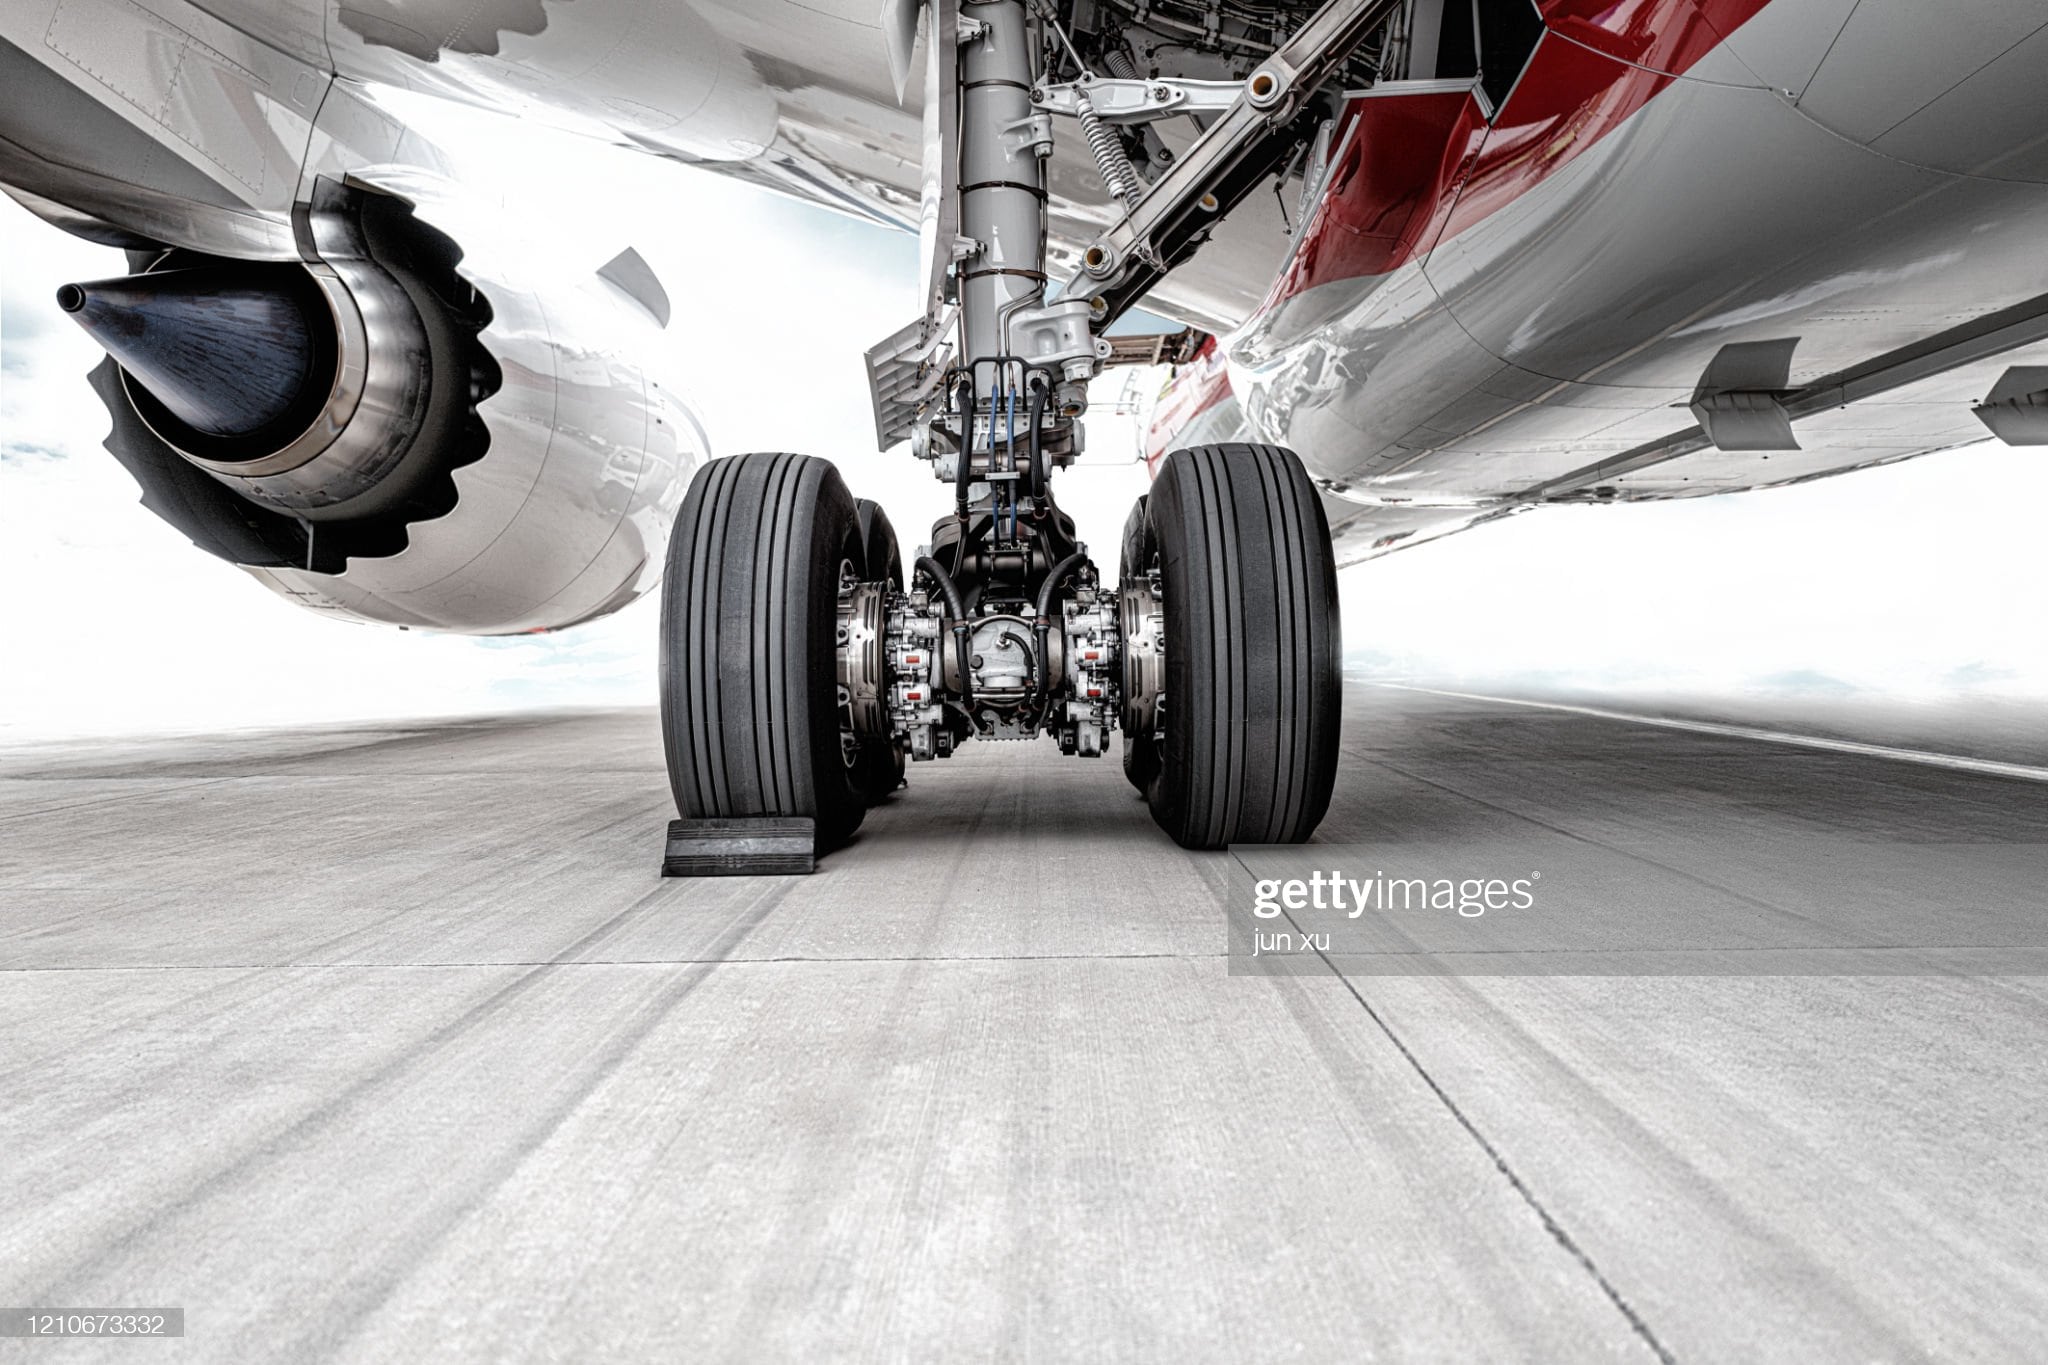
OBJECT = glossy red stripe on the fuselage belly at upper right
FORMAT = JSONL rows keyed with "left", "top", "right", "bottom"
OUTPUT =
{"left": 1260, "top": 0, "right": 1769, "bottom": 311}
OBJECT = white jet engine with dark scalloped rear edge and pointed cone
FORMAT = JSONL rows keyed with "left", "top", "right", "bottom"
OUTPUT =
{"left": 72, "top": 180, "right": 707, "bottom": 634}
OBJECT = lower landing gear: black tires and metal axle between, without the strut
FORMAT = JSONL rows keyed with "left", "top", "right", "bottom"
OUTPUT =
{"left": 662, "top": 437, "right": 1341, "bottom": 849}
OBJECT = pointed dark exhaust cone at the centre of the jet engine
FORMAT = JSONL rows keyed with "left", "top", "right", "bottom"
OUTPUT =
{"left": 57, "top": 262, "right": 334, "bottom": 444}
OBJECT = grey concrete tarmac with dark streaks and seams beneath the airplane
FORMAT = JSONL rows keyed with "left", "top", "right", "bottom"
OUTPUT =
{"left": 0, "top": 686, "right": 2048, "bottom": 1361}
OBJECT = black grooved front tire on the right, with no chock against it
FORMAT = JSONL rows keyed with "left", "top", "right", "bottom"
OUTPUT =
{"left": 1145, "top": 444, "right": 1343, "bottom": 849}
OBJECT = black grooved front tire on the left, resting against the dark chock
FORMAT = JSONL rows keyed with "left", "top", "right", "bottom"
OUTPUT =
{"left": 662, "top": 452, "right": 866, "bottom": 849}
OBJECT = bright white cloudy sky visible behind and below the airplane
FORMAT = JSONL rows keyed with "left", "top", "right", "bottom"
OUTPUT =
{"left": 0, "top": 92, "right": 2048, "bottom": 741}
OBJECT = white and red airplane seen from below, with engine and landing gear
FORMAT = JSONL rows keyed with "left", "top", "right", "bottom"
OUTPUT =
{"left": 0, "top": 0, "right": 2048, "bottom": 849}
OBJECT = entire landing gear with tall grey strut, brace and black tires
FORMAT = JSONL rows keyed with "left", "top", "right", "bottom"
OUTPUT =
{"left": 662, "top": 0, "right": 1395, "bottom": 870}
